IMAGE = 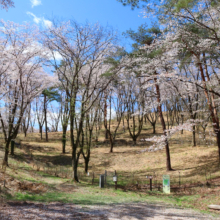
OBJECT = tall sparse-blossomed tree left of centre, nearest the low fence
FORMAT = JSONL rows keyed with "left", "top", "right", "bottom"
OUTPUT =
{"left": 44, "top": 21, "right": 121, "bottom": 181}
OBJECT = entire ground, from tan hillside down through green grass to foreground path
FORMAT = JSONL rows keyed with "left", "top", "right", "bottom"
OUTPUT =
{"left": 0, "top": 122, "right": 220, "bottom": 219}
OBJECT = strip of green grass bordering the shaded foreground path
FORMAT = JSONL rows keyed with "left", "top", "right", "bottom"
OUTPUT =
{"left": 9, "top": 184, "right": 217, "bottom": 216}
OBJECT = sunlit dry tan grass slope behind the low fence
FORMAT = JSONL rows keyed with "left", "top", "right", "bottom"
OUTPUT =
{"left": 14, "top": 121, "right": 220, "bottom": 185}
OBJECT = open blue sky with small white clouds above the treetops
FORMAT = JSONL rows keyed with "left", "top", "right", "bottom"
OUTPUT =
{"left": 1, "top": 0, "right": 151, "bottom": 50}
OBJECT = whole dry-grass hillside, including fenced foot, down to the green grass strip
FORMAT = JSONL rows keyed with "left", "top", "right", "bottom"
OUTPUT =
{"left": 0, "top": 119, "right": 220, "bottom": 216}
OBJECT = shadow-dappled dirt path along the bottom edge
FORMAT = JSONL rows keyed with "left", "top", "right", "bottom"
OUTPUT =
{"left": 0, "top": 202, "right": 220, "bottom": 220}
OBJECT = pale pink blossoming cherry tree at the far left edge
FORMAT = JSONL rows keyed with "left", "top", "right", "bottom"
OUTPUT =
{"left": 0, "top": 21, "right": 53, "bottom": 165}
